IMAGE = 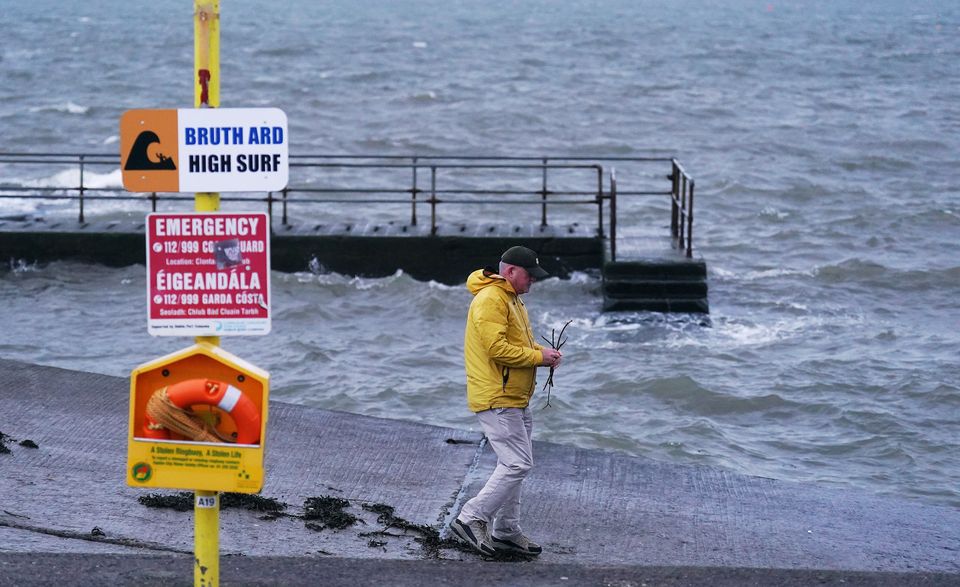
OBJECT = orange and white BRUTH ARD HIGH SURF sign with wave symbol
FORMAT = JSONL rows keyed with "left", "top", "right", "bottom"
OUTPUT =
{"left": 120, "top": 108, "right": 289, "bottom": 192}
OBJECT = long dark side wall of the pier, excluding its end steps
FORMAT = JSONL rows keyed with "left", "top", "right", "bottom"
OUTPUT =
{"left": 0, "top": 217, "right": 604, "bottom": 284}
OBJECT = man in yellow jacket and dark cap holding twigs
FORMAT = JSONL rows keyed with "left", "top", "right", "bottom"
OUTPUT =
{"left": 450, "top": 247, "right": 561, "bottom": 555}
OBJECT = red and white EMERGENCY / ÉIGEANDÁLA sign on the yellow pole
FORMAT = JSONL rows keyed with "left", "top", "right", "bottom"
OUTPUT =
{"left": 147, "top": 212, "right": 270, "bottom": 336}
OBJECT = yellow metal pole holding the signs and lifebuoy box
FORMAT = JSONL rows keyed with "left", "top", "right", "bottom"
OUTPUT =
{"left": 193, "top": 0, "right": 220, "bottom": 587}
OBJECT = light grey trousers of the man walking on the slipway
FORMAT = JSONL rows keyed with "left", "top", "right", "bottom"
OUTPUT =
{"left": 458, "top": 407, "right": 533, "bottom": 538}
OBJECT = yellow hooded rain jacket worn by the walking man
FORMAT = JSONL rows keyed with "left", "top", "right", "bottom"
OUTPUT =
{"left": 463, "top": 269, "right": 543, "bottom": 412}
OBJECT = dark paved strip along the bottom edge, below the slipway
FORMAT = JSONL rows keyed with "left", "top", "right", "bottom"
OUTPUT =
{"left": 0, "top": 553, "right": 957, "bottom": 587}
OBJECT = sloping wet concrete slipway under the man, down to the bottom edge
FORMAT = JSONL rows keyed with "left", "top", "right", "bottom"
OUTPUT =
{"left": 0, "top": 359, "right": 960, "bottom": 585}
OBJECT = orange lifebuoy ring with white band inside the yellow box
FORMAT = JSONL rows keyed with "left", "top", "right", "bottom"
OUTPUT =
{"left": 143, "top": 379, "right": 260, "bottom": 444}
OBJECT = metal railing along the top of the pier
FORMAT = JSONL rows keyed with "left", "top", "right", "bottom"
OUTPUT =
{"left": 0, "top": 153, "right": 694, "bottom": 260}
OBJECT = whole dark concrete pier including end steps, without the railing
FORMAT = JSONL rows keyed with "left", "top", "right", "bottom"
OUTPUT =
{"left": 0, "top": 217, "right": 709, "bottom": 313}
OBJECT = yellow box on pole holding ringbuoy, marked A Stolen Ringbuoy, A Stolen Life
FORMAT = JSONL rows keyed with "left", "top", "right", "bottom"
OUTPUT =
{"left": 127, "top": 342, "right": 270, "bottom": 493}
